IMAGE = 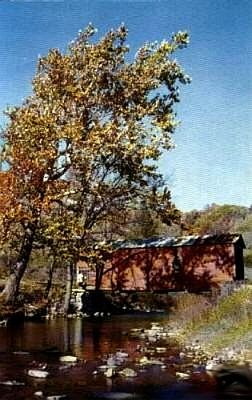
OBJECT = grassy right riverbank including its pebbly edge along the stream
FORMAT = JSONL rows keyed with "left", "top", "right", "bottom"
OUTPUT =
{"left": 167, "top": 285, "right": 252, "bottom": 370}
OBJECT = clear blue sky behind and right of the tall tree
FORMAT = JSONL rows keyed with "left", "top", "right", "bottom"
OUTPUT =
{"left": 0, "top": 0, "right": 252, "bottom": 211}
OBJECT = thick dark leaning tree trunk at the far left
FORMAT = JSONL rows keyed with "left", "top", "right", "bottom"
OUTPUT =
{"left": 1, "top": 229, "right": 35, "bottom": 304}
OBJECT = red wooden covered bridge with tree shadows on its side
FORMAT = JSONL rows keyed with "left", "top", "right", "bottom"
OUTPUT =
{"left": 78, "top": 234, "right": 245, "bottom": 292}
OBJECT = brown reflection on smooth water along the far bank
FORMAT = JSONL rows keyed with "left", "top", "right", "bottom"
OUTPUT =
{"left": 0, "top": 315, "right": 164, "bottom": 359}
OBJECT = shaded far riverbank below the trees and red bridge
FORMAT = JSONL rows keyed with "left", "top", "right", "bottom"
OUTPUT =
{"left": 0, "top": 286, "right": 174, "bottom": 325}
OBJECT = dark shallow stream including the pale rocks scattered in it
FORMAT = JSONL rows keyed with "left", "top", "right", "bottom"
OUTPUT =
{"left": 0, "top": 315, "right": 219, "bottom": 400}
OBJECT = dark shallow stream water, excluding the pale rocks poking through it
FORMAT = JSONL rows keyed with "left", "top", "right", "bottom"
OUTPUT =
{"left": 0, "top": 314, "right": 221, "bottom": 400}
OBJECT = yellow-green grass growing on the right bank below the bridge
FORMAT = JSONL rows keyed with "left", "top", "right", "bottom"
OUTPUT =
{"left": 172, "top": 286, "right": 252, "bottom": 353}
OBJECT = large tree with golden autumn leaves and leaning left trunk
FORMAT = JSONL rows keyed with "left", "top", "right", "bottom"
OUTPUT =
{"left": 2, "top": 25, "right": 189, "bottom": 302}
